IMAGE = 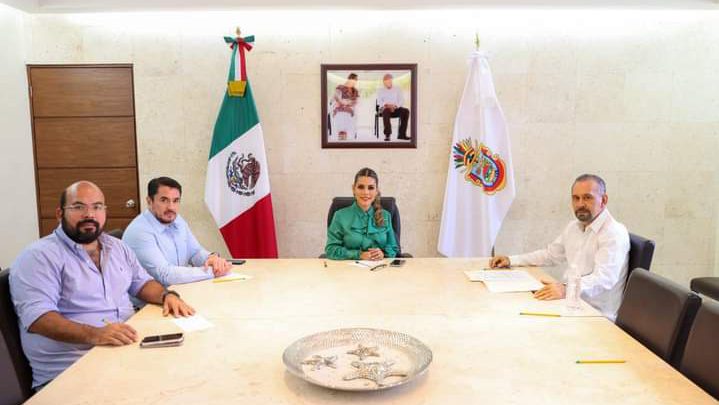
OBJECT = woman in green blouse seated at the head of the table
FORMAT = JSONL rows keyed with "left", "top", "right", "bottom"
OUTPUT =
{"left": 325, "top": 168, "right": 399, "bottom": 260}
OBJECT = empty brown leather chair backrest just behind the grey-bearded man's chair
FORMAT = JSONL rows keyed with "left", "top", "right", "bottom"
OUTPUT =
{"left": 617, "top": 268, "right": 701, "bottom": 366}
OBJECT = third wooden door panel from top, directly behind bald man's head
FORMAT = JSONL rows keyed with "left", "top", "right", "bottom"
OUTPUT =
{"left": 38, "top": 168, "right": 140, "bottom": 218}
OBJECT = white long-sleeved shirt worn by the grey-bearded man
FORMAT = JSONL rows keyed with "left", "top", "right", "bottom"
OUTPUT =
{"left": 509, "top": 208, "right": 629, "bottom": 321}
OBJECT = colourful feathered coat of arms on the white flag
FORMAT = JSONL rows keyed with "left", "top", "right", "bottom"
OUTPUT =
{"left": 452, "top": 138, "right": 507, "bottom": 195}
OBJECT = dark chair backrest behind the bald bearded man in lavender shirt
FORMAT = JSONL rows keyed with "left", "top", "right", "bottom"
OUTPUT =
{"left": 0, "top": 269, "right": 33, "bottom": 405}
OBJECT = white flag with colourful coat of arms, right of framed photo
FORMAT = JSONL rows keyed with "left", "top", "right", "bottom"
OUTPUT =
{"left": 437, "top": 51, "right": 515, "bottom": 257}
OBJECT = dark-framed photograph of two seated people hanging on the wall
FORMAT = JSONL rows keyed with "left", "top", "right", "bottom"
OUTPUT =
{"left": 320, "top": 64, "right": 417, "bottom": 148}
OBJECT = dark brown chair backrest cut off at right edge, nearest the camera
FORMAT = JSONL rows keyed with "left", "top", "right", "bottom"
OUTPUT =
{"left": 679, "top": 300, "right": 719, "bottom": 399}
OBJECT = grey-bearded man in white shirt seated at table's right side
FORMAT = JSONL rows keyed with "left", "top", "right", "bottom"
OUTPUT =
{"left": 489, "top": 174, "right": 629, "bottom": 320}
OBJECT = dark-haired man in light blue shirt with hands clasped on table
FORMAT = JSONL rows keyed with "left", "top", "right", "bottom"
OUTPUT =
{"left": 122, "top": 177, "right": 232, "bottom": 286}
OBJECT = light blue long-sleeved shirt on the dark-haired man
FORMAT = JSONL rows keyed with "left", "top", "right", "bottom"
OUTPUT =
{"left": 122, "top": 210, "right": 214, "bottom": 287}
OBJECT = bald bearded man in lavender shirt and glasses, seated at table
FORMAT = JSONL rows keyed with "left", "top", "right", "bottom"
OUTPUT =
{"left": 10, "top": 181, "right": 194, "bottom": 390}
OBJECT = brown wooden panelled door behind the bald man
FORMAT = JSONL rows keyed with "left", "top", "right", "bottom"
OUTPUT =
{"left": 28, "top": 65, "right": 139, "bottom": 236}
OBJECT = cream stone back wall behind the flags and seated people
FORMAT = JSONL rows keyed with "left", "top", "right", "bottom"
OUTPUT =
{"left": 19, "top": 10, "right": 719, "bottom": 282}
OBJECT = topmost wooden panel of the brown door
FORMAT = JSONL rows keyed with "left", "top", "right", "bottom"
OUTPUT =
{"left": 30, "top": 66, "right": 134, "bottom": 117}
